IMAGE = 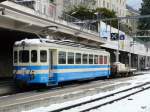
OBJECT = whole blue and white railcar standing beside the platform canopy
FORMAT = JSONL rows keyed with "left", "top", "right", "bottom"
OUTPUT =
{"left": 13, "top": 39, "right": 110, "bottom": 85}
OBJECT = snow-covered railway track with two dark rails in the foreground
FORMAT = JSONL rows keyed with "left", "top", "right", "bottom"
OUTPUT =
{"left": 49, "top": 82, "right": 150, "bottom": 112}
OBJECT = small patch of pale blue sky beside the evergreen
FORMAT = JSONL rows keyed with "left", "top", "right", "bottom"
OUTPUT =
{"left": 127, "top": 0, "right": 142, "bottom": 9}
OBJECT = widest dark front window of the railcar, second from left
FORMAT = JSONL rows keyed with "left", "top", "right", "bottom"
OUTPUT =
{"left": 19, "top": 50, "right": 29, "bottom": 63}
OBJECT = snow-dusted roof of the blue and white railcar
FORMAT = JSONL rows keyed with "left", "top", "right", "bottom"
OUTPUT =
{"left": 14, "top": 38, "right": 106, "bottom": 52}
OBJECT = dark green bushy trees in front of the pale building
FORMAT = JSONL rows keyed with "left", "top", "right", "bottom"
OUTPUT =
{"left": 65, "top": 5, "right": 118, "bottom": 28}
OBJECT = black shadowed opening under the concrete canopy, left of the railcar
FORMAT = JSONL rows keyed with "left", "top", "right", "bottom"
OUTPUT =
{"left": 0, "top": 28, "right": 35, "bottom": 78}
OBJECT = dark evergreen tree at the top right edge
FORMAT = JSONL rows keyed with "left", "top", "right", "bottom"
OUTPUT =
{"left": 138, "top": 0, "right": 150, "bottom": 30}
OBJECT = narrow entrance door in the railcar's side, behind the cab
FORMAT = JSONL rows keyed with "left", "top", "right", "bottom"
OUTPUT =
{"left": 49, "top": 49, "right": 53, "bottom": 77}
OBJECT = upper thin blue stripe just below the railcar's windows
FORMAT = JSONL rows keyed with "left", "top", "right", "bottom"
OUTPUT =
{"left": 14, "top": 65, "right": 110, "bottom": 70}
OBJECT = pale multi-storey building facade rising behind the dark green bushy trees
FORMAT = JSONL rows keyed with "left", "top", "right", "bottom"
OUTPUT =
{"left": 63, "top": 0, "right": 126, "bottom": 17}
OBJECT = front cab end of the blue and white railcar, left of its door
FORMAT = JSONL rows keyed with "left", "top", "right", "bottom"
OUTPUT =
{"left": 13, "top": 41, "right": 49, "bottom": 86}
